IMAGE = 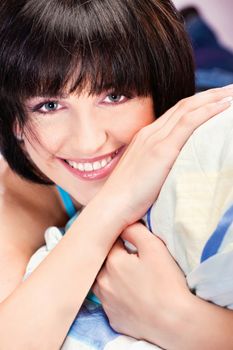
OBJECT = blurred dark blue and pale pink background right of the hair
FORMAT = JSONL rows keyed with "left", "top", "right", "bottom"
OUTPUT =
{"left": 173, "top": 0, "right": 233, "bottom": 91}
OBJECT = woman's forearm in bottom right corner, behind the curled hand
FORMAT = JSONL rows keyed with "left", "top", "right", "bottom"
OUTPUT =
{"left": 147, "top": 293, "right": 233, "bottom": 350}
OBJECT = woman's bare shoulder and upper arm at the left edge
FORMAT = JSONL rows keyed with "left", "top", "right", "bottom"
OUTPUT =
{"left": 0, "top": 160, "right": 66, "bottom": 301}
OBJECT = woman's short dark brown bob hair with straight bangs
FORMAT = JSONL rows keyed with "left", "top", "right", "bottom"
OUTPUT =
{"left": 0, "top": 0, "right": 194, "bottom": 183}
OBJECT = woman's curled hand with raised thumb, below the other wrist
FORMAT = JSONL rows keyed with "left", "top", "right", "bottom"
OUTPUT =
{"left": 94, "top": 223, "right": 191, "bottom": 345}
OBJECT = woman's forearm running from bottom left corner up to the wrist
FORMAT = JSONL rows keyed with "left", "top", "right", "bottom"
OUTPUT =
{"left": 0, "top": 194, "right": 124, "bottom": 350}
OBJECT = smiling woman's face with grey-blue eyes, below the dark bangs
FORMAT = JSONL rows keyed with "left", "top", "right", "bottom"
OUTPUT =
{"left": 24, "top": 92, "right": 155, "bottom": 205}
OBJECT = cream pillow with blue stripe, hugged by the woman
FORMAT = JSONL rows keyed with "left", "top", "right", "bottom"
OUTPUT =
{"left": 145, "top": 102, "right": 233, "bottom": 308}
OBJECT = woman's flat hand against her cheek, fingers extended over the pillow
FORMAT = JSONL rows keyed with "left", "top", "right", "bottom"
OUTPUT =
{"left": 98, "top": 87, "right": 233, "bottom": 228}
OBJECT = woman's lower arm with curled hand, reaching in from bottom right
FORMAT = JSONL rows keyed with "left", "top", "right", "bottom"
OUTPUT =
{"left": 94, "top": 224, "right": 233, "bottom": 350}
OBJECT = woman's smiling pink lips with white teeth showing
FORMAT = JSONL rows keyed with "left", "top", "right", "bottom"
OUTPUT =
{"left": 59, "top": 146, "right": 125, "bottom": 181}
